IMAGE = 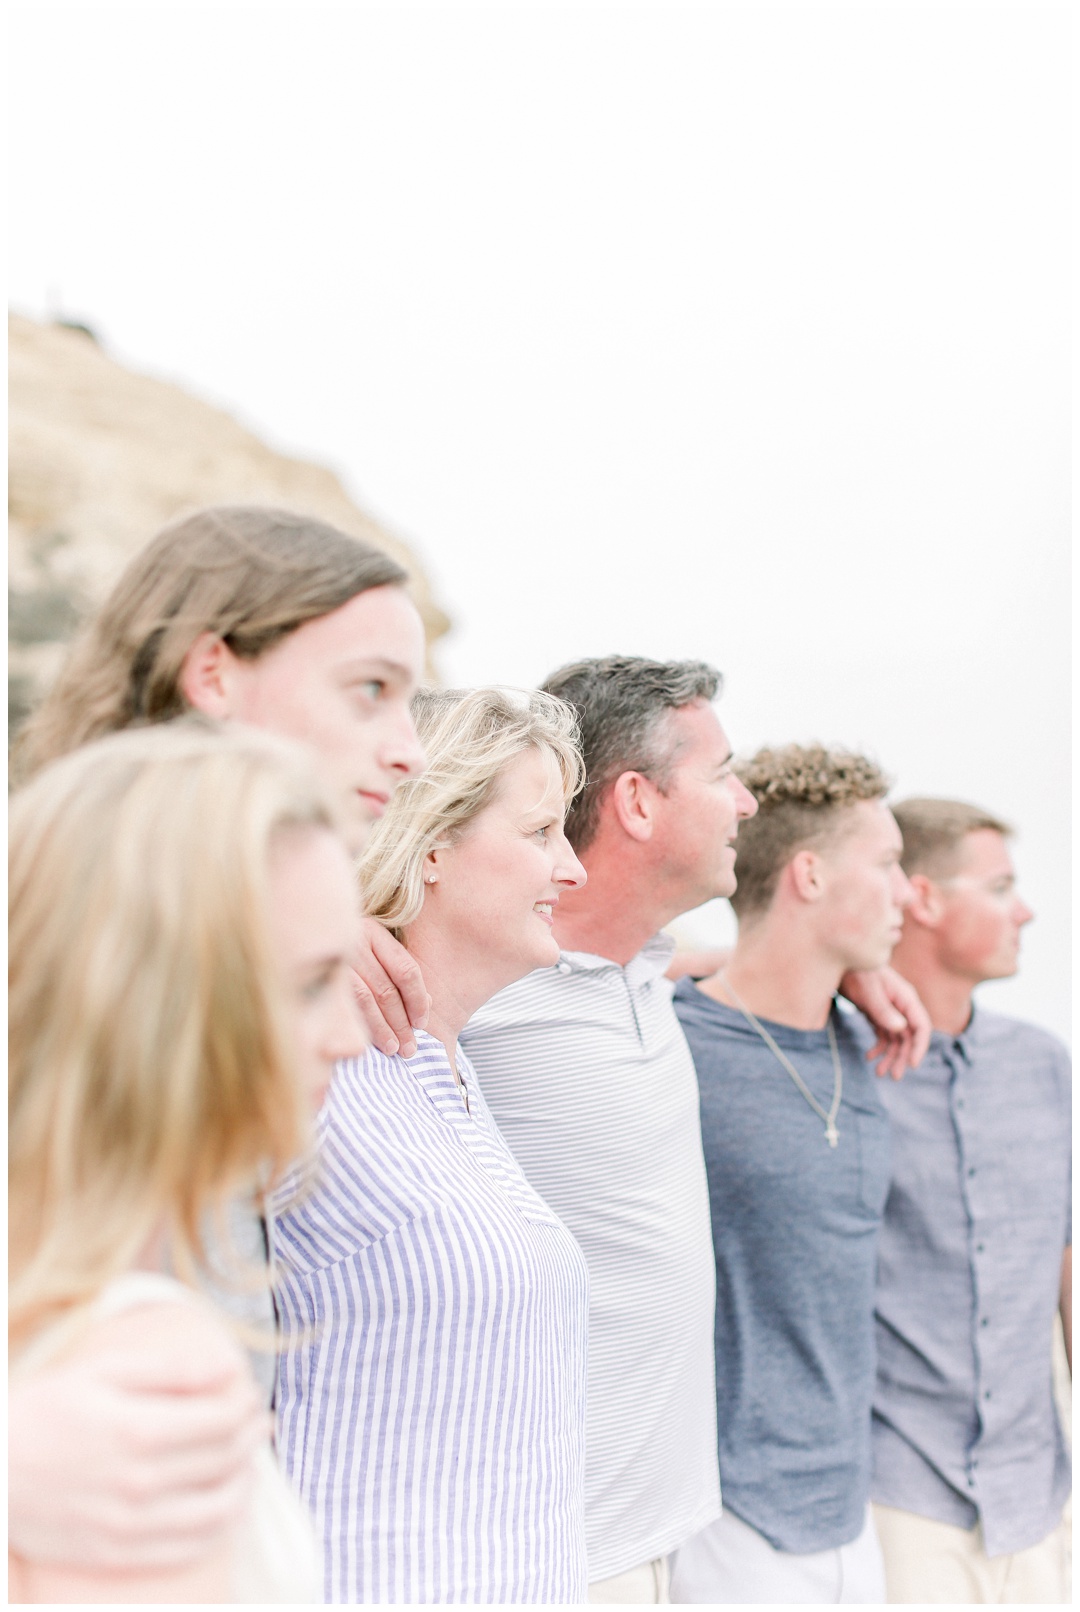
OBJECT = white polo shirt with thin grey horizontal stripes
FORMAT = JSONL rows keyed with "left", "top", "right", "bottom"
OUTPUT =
{"left": 461, "top": 935, "right": 721, "bottom": 1581}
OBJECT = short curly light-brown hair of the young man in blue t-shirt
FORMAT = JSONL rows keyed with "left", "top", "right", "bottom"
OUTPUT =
{"left": 730, "top": 745, "right": 890, "bottom": 919}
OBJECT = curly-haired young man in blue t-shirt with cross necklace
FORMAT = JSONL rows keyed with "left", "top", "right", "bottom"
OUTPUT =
{"left": 672, "top": 745, "right": 911, "bottom": 1602}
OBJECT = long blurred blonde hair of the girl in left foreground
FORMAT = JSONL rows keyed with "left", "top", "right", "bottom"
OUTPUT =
{"left": 8, "top": 717, "right": 343, "bottom": 1336}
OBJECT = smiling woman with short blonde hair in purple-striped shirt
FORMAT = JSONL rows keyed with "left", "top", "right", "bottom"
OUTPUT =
{"left": 276, "top": 688, "right": 588, "bottom": 1602}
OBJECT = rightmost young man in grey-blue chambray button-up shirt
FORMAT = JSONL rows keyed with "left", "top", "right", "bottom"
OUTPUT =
{"left": 872, "top": 800, "right": 1072, "bottom": 1602}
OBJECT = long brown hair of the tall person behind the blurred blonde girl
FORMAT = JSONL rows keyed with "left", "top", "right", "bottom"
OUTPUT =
{"left": 15, "top": 505, "right": 408, "bottom": 777}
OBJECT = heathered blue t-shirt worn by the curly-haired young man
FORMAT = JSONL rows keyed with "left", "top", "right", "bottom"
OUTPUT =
{"left": 675, "top": 980, "right": 888, "bottom": 1552}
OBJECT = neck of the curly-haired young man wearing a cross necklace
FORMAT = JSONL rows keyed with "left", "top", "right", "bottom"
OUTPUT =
{"left": 701, "top": 916, "right": 843, "bottom": 1030}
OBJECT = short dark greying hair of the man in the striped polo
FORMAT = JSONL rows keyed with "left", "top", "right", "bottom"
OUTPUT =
{"left": 542, "top": 654, "right": 722, "bottom": 851}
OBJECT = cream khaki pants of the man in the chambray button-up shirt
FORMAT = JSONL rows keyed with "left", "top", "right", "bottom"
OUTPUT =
{"left": 874, "top": 1506, "right": 1072, "bottom": 1606}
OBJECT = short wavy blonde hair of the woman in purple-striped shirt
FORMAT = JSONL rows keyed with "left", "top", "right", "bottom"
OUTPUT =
{"left": 359, "top": 688, "right": 585, "bottom": 940}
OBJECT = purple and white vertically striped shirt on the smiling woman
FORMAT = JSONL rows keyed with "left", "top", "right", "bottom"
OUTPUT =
{"left": 274, "top": 1035, "right": 588, "bottom": 1602}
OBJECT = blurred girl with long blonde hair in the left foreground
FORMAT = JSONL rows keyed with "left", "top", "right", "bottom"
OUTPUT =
{"left": 8, "top": 724, "right": 372, "bottom": 1602}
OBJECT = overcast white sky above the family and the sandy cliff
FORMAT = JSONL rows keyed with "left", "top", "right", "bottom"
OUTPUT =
{"left": 10, "top": 0, "right": 1070, "bottom": 1035}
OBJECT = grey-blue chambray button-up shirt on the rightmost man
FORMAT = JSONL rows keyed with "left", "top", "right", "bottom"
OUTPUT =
{"left": 872, "top": 1011, "right": 1072, "bottom": 1556}
